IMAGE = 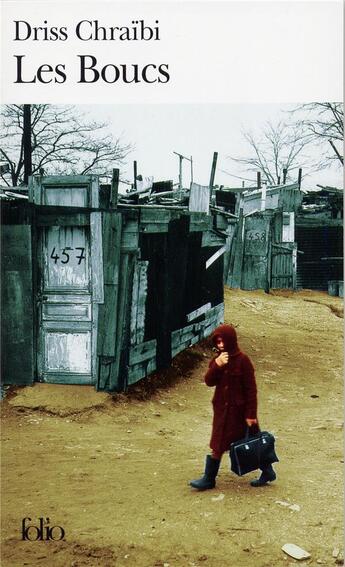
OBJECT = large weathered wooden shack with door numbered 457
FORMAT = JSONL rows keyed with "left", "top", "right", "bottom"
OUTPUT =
{"left": 2, "top": 175, "right": 226, "bottom": 391}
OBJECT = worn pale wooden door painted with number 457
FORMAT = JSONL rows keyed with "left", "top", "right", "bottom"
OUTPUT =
{"left": 38, "top": 226, "right": 94, "bottom": 384}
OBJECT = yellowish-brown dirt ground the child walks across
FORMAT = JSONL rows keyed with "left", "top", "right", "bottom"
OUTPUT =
{"left": 1, "top": 289, "right": 344, "bottom": 567}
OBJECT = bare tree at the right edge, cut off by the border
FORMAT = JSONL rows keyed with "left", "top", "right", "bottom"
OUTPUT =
{"left": 292, "top": 102, "right": 344, "bottom": 166}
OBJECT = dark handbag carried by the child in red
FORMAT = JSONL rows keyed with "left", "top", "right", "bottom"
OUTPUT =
{"left": 230, "top": 427, "right": 279, "bottom": 476}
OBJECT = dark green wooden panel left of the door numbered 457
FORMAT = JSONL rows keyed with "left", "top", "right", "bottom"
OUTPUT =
{"left": 1, "top": 225, "right": 34, "bottom": 384}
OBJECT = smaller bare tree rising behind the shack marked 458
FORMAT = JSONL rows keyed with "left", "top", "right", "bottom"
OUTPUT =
{"left": 229, "top": 121, "right": 315, "bottom": 185}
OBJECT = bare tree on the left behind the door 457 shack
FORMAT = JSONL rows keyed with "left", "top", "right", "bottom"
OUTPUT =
{"left": 0, "top": 104, "right": 132, "bottom": 186}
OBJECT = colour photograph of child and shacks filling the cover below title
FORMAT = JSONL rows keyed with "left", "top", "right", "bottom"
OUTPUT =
{"left": 0, "top": 102, "right": 344, "bottom": 567}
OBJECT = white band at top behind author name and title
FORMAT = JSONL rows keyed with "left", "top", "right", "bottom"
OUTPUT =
{"left": 2, "top": 0, "right": 343, "bottom": 104}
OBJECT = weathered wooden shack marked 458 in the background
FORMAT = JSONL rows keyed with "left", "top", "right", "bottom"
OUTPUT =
{"left": 217, "top": 183, "right": 302, "bottom": 291}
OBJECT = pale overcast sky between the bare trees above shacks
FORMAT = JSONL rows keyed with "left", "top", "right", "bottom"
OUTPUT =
{"left": 79, "top": 104, "right": 343, "bottom": 192}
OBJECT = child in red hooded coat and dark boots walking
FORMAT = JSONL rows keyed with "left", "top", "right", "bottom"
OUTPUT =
{"left": 190, "top": 325, "right": 276, "bottom": 490}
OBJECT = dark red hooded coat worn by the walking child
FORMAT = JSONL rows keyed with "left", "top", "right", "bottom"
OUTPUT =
{"left": 205, "top": 325, "right": 258, "bottom": 453}
